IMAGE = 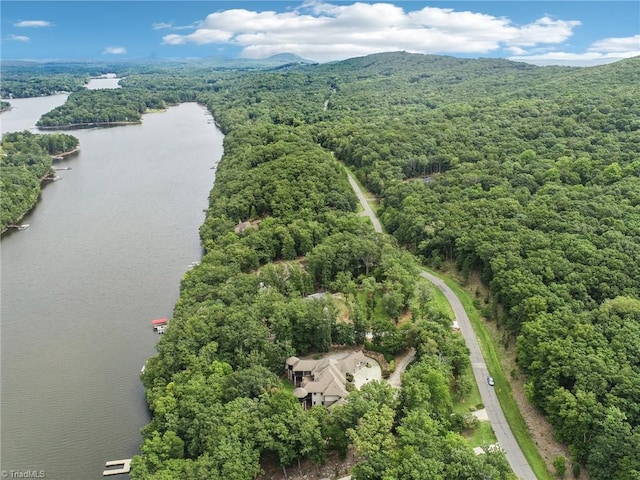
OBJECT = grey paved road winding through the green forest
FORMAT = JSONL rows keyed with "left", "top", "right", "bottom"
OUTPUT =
{"left": 347, "top": 172, "right": 536, "bottom": 480}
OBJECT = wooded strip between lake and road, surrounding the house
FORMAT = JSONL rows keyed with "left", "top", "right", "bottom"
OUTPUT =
{"left": 132, "top": 55, "right": 513, "bottom": 479}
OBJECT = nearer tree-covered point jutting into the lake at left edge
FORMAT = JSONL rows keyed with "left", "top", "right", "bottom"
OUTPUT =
{"left": 0, "top": 130, "right": 79, "bottom": 232}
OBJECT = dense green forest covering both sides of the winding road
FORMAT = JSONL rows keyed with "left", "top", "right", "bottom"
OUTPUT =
{"left": 8, "top": 53, "right": 640, "bottom": 480}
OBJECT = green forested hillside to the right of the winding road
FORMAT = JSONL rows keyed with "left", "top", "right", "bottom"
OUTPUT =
{"left": 316, "top": 54, "right": 640, "bottom": 479}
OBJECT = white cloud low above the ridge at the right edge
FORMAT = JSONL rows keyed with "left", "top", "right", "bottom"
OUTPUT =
{"left": 509, "top": 35, "right": 640, "bottom": 67}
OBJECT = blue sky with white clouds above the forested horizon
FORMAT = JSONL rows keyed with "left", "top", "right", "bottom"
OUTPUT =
{"left": 0, "top": 0, "right": 640, "bottom": 65}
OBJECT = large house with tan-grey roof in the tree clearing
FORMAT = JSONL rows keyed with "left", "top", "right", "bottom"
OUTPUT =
{"left": 286, "top": 351, "right": 368, "bottom": 408}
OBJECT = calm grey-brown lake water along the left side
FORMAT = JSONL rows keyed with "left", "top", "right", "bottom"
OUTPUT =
{"left": 0, "top": 89, "right": 222, "bottom": 480}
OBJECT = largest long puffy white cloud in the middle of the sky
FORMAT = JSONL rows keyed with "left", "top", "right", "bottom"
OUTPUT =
{"left": 163, "top": 1, "right": 580, "bottom": 61}
